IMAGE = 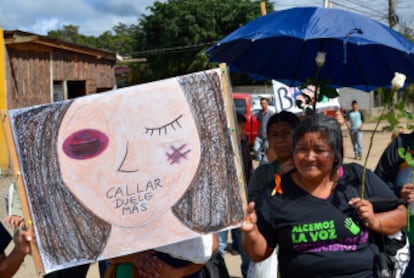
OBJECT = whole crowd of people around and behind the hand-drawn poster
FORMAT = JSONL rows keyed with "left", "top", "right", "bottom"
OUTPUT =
{"left": 0, "top": 96, "right": 414, "bottom": 278}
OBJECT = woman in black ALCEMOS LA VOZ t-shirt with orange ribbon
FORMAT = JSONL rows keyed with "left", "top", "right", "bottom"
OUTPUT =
{"left": 242, "top": 114, "right": 407, "bottom": 278}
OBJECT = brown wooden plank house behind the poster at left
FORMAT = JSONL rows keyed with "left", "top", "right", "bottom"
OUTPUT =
{"left": 0, "top": 29, "right": 116, "bottom": 169}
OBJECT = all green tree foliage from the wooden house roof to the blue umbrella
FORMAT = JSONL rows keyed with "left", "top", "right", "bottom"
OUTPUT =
{"left": 48, "top": 0, "right": 273, "bottom": 84}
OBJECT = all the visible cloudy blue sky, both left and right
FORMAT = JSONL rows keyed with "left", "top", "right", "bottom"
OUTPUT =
{"left": 0, "top": 0, "right": 414, "bottom": 36}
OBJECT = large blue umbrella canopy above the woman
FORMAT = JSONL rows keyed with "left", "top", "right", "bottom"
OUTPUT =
{"left": 207, "top": 7, "right": 414, "bottom": 91}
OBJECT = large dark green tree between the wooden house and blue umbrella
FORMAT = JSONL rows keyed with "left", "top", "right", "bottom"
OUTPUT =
{"left": 134, "top": 0, "right": 273, "bottom": 83}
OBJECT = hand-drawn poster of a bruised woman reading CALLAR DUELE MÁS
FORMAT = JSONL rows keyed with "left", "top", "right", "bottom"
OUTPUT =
{"left": 3, "top": 69, "right": 245, "bottom": 273}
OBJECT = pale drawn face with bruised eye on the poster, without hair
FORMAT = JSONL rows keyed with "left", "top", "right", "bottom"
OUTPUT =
{"left": 58, "top": 79, "right": 200, "bottom": 227}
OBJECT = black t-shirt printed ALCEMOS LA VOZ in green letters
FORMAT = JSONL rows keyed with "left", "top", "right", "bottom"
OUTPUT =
{"left": 256, "top": 163, "right": 396, "bottom": 278}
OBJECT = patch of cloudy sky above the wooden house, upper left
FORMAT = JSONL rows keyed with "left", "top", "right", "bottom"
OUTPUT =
{"left": 0, "top": 0, "right": 165, "bottom": 36}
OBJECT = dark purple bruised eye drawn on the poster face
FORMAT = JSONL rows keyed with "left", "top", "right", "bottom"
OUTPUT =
{"left": 62, "top": 129, "right": 109, "bottom": 159}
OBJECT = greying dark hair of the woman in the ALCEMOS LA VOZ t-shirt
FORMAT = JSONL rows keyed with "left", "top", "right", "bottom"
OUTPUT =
{"left": 293, "top": 114, "right": 344, "bottom": 175}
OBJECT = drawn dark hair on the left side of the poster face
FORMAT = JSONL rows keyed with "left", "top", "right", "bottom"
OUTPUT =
{"left": 10, "top": 101, "right": 111, "bottom": 273}
